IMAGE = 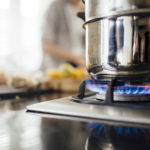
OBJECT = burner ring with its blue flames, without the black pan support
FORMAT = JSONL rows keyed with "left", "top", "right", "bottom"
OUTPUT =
{"left": 85, "top": 80, "right": 150, "bottom": 101}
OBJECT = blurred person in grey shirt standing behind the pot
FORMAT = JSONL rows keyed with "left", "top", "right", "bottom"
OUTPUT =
{"left": 42, "top": 0, "right": 85, "bottom": 70}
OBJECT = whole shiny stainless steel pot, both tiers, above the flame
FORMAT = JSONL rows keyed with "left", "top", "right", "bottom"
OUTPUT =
{"left": 84, "top": 0, "right": 150, "bottom": 79}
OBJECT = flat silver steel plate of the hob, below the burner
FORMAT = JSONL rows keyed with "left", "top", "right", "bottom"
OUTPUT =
{"left": 27, "top": 97, "right": 150, "bottom": 125}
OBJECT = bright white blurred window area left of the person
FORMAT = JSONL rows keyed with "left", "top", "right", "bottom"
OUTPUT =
{"left": 0, "top": 0, "right": 53, "bottom": 73}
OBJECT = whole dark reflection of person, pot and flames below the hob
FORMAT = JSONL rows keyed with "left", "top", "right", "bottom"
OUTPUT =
{"left": 41, "top": 118, "right": 150, "bottom": 150}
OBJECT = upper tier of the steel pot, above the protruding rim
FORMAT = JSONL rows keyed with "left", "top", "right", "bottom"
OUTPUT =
{"left": 83, "top": 0, "right": 150, "bottom": 20}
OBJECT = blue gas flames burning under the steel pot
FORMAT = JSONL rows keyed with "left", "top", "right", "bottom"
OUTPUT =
{"left": 86, "top": 80, "right": 150, "bottom": 95}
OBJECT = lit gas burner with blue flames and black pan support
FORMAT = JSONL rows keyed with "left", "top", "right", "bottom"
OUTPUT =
{"left": 71, "top": 78, "right": 150, "bottom": 108}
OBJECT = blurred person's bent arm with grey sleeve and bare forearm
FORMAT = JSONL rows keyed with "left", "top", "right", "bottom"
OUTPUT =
{"left": 42, "top": 1, "right": 85, "bottom": 66}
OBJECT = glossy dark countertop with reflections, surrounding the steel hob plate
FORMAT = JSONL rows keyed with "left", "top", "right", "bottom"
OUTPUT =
{"left": 0, "top": 93, "right": 150, "bottom": 150}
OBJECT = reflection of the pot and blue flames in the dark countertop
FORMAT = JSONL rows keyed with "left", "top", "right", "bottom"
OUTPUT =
{"left": 85, "top": 124, "right": 150, "bottom": 150}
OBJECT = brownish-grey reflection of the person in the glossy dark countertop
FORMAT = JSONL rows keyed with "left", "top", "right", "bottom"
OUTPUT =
{"left": 41, "top": 118, "right": 88, "bottom": 150}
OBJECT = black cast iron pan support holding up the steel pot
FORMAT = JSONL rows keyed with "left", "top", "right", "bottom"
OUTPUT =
{"left": 70, "top": 77, "right": 150, "bottom": 109}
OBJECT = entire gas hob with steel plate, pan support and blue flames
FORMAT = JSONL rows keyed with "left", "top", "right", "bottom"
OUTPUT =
{"left": 27, "top": 80, "right": 150, "bottom": 125}
